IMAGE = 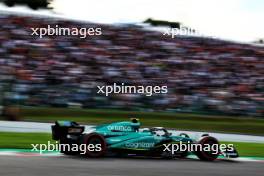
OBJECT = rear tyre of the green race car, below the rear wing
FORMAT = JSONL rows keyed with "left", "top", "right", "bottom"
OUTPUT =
{"left": 84, "top": 133, "right": 106, "bottom": 158}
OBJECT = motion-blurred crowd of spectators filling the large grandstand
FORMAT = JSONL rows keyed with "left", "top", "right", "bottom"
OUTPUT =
{"left": 0, "top": 14, "right": 264, "bottom": 116}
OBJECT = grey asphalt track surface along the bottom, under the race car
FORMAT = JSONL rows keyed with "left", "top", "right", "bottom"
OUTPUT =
{"left": 0, "top": 156, "right": 264, "bottom": 176}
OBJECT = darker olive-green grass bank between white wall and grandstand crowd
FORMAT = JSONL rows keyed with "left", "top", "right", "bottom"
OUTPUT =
{"left": 13, "top": 108, "right": 264, "bottom": 135}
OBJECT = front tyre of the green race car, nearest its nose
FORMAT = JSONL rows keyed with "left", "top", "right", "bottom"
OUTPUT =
{"left": 195, "top": 136, "right": 219, "bottom": 161}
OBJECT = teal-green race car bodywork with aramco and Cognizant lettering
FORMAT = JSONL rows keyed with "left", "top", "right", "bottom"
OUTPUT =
{"left": 90, "top": 121, "right": 193, "bottom": 150}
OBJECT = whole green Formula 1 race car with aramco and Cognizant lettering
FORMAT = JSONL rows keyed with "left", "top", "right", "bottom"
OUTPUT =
{"left": 52, "top": 119, "right": 238, "bottom": 161}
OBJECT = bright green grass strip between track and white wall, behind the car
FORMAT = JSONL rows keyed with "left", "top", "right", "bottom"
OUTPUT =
{"left": 0, "top": 132, "right": 264, "bottom": 157}
